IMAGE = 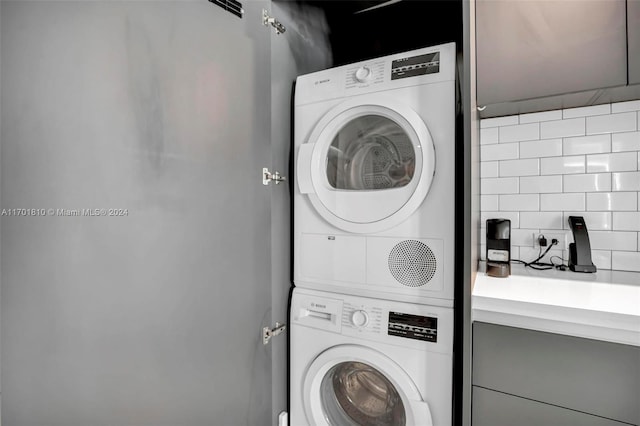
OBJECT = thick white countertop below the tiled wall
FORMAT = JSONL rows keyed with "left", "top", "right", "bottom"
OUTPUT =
{"left": 471, "top": 265, "right": 640, "bottom": 346}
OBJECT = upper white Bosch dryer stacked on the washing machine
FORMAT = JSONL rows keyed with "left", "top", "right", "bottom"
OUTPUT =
{"left": 294, "top": 43, "right": 456, "bottom": 307}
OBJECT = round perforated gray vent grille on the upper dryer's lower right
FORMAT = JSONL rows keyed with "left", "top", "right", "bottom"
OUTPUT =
{"left": 389, "top": 240, "right": 437, "bottom": 287}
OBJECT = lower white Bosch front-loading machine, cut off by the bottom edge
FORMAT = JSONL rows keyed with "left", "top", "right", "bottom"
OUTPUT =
{"left": 289, "top": 288, "right": 453, "bottom": 426}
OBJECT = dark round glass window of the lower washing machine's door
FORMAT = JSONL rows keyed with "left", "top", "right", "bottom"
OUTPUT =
{"left": 320, "top": 361, "right": 406, "bottom": 426}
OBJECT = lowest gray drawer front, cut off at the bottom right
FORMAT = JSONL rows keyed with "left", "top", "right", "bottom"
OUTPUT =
{"left": 472, "top": 386, "right": 626, "bottom": 426}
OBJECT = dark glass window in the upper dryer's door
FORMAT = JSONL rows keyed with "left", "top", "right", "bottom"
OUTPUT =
{"left": 326, "top": 114, "right": 416, "bottom": 191}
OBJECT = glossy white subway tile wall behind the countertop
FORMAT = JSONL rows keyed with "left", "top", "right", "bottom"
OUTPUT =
{"left": 480, "top": 100, "right": 640, "bottom": 271}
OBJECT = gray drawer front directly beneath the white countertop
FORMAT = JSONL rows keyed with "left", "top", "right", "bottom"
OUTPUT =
{"left": 473, "top": 322, "right": 640, "bottom": 424}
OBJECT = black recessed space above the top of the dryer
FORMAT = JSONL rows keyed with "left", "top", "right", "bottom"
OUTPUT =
{"left": 299, "top": 0, "right": 462, "bottom": 66}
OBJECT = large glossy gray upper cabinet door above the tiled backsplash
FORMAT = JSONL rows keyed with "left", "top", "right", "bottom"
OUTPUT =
{"left": 476, "top": 0, "right": 628, "bottom": 105}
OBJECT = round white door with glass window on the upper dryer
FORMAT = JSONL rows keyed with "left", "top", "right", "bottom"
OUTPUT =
{"left": 297, "top": 96, "right": 438, "bottom": 233}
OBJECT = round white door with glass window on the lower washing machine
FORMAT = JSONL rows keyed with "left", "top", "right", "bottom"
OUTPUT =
{"left": 303, "top": 345, "right": 432, "bottom": 426}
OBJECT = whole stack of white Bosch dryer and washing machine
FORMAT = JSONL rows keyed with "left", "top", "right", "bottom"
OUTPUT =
{"left": 290, "top": 43, "right": 456, "bottom": 426}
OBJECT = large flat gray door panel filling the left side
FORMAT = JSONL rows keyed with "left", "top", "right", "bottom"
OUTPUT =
{"left": 0, "top": 1, "right": 272, "bottom": 426}
